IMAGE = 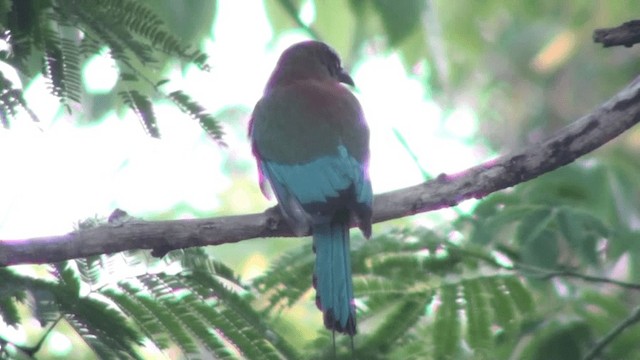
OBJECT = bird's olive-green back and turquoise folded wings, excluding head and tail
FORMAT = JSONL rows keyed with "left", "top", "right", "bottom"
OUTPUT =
{"left": 250, "top": 82, "right": 372, "bottom": 231}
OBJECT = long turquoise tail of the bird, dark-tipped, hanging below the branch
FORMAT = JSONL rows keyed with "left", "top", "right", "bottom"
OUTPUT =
{"left": 313, "top": 218, "right": 356, "bottom": 336}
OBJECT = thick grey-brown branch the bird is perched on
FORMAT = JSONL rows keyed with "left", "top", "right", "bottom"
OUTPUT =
{"left": 0, "top": 75, "right": 640, "bottom": 266}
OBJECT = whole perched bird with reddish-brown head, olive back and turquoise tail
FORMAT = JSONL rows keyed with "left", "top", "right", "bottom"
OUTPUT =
{"left": 249, "top": 41, "right": 373, "bottom": 336}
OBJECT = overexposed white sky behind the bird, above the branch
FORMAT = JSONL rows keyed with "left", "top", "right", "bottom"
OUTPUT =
{"left": 0, "top": 0, "right": 487, "bottom": 239}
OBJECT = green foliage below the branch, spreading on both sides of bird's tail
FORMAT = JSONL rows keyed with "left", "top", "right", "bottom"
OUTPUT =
{"left": 7, "top": 154, "right": 640, "bottom": 359}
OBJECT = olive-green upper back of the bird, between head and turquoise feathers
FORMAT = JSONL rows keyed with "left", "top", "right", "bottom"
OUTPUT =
{"left": 250, "top": 80, "right": 369, "bottom": 164}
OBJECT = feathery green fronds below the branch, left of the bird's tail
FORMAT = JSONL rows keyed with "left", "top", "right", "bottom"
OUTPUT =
{"left": 0, "top": 249, "right": 296, "bottom": 359}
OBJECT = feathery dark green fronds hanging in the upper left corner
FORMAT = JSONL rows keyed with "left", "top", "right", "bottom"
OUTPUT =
{"left": 0, "top": 0, "right": 222, "bottom": 141}
